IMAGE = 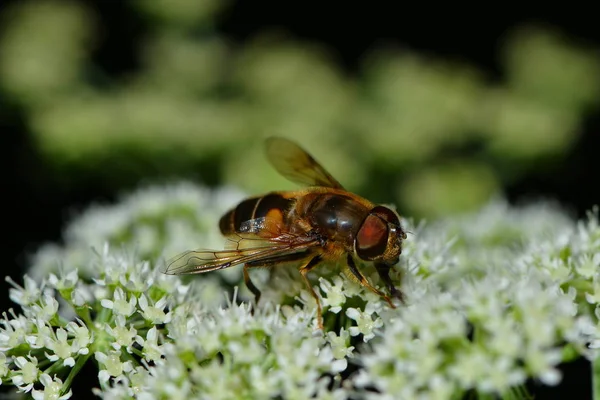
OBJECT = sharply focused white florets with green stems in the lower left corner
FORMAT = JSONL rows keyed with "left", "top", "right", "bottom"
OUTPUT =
{"left": 0, "top": 246, "right": 188, "bottom": 399}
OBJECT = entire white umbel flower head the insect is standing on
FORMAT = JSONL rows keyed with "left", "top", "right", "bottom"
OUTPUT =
{"left": 0, "top": 184, "right": 600, "bottom": 399}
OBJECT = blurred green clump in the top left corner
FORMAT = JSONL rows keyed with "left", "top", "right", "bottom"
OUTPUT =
{"left": 0, "top": 0, "right": 94, "bottom": 108}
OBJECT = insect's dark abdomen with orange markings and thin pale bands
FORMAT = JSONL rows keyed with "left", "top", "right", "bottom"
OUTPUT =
{"left": 219, "top": 193, "right": 294, "bottom": 236}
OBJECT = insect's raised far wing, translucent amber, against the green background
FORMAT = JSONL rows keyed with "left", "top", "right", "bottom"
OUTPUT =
{"left": 266, "top": 137, "right": 343, "bottom": 189}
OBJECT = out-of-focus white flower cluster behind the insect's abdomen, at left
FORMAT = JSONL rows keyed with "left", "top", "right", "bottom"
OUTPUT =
{"left": 29, "top": 182, "right": 243, "bottom": 281}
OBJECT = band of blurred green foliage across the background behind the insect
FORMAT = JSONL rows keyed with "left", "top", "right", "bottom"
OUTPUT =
{"left": 0, "top": 0, "right": 600, "bottom": 218}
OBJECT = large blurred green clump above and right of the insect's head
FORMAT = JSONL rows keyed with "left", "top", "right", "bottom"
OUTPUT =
{"left": 355, "top": 52, "right": 484, "bottom": 166}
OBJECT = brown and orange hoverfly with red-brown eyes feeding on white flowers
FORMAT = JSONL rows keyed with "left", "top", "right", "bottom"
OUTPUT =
{"left": 165, "top": 137, "right": 406, "bottom": 330}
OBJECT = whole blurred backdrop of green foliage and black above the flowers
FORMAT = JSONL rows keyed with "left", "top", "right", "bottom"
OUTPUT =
{"left": 0, "top": 0, "right": 600, "bottom": 292}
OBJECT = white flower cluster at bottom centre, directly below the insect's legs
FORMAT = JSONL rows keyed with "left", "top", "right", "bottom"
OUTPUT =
{"left": 96, "top": 296, "right": 346, "bottom": 400}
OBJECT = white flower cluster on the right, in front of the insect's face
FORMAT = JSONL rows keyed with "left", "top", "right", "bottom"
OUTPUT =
{"left": 352, "top": 203, "right": 600, "bottom": 399}
